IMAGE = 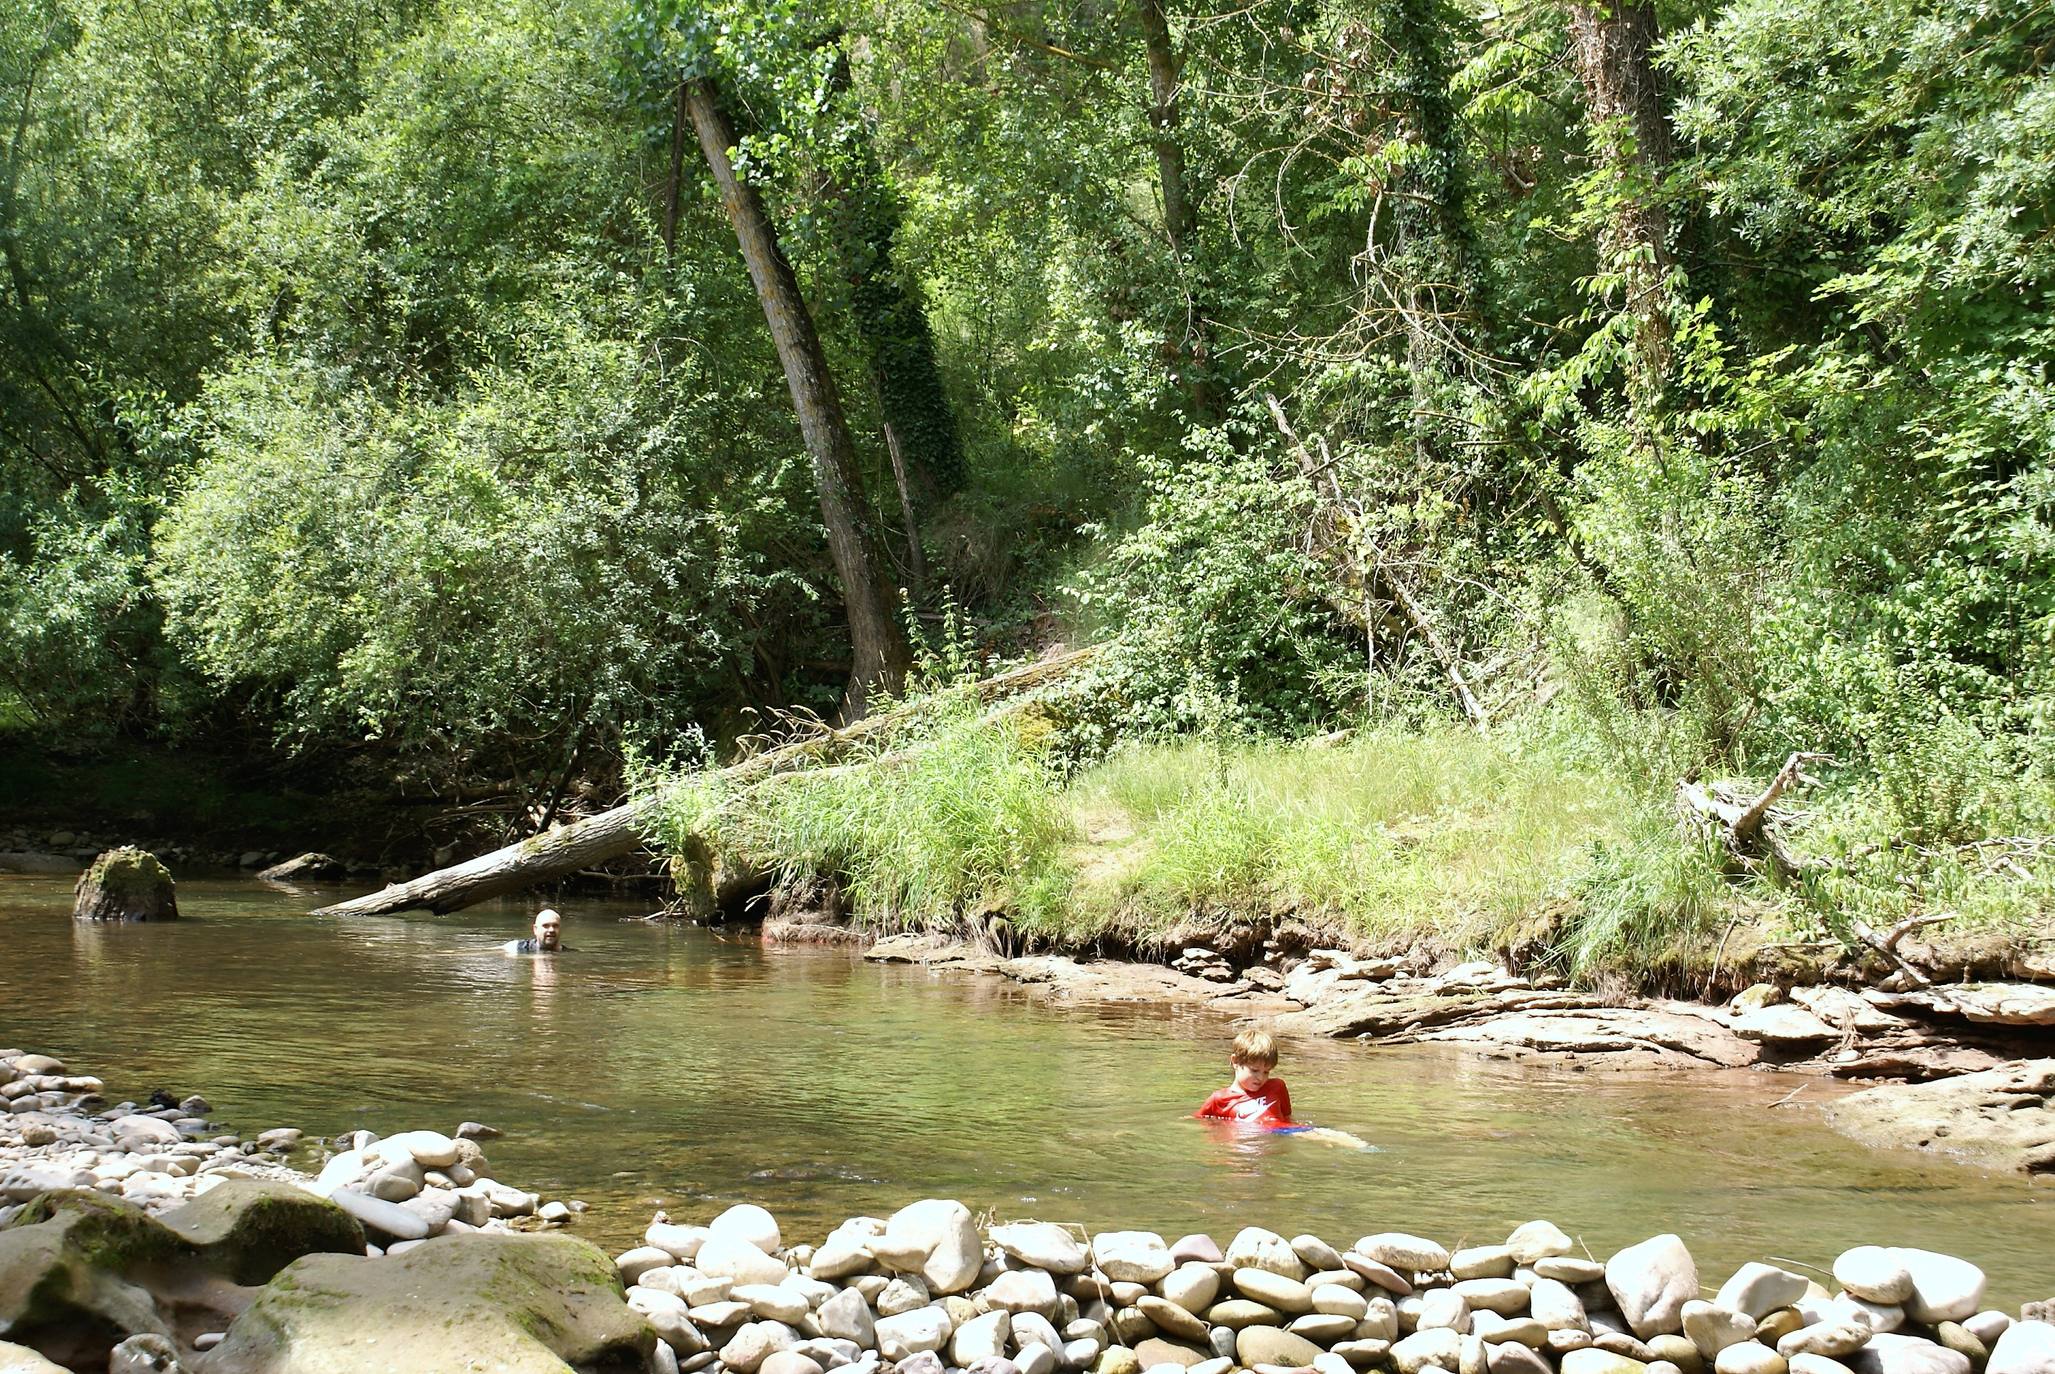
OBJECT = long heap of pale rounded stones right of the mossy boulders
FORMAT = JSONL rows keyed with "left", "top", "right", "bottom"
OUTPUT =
{"left": 600, "top": 1199, "right": 2055, "bottom": 1374}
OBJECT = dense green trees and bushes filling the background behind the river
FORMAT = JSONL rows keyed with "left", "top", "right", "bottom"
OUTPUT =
{"left": 0, "top": 0, "right": 2055, "bottom": 834}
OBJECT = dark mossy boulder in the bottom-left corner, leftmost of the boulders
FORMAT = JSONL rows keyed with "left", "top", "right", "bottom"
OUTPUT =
{"left": 0, "top": 1193, "right": 187, "bottom": 1368}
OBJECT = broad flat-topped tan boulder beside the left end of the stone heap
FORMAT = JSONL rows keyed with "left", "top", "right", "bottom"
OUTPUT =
{"left": 208, "top": 1234, "right": 656, "bottom": 1374}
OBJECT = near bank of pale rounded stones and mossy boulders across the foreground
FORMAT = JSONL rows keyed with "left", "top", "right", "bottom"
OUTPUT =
{"left": 0, "top": 1052, "right": 2055, "bottom": 1374}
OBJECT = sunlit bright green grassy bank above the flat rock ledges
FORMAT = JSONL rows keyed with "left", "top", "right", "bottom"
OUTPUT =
{"left": 649, "top": 690, "right": 2055, "bottom": 988}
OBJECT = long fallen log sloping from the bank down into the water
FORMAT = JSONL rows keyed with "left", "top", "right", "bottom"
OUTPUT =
{"left": 314, "top": 647, "right": 1097, "bottom": 916}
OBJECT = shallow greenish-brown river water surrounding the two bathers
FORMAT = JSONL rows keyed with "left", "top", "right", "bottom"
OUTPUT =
{"left": 0, "top": 877, "right": 2055, "bottom": 1306}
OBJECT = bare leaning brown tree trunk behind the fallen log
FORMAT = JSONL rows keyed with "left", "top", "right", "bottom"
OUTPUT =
{"left": 684, "top": 78, "right": 912, "bottom": 719}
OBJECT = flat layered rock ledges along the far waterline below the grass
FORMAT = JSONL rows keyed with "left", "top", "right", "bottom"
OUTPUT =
{"left": 846, "top": 922, "right": 2055, "bottom": 1173}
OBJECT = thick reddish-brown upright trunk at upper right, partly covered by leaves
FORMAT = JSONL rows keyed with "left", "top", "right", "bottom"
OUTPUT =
{"left": 1570, "top": 0, "right": 1671, "bottom": 407}
